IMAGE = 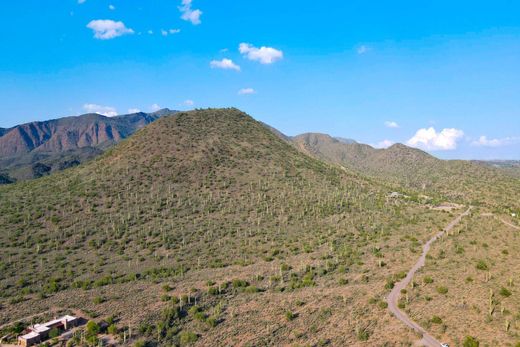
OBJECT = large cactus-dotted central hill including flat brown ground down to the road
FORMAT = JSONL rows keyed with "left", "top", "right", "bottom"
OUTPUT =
{"left": 0, "top": 109, "right": 444, "bottom": 346}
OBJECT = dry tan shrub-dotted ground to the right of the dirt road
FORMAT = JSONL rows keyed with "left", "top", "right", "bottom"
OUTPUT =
{"left": 407, "top": 213, "right": 520, "bottom": 346}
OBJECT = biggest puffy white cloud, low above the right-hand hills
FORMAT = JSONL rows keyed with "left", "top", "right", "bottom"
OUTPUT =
{"left": 407, "top": 127, "right": 464, "bottom": 151}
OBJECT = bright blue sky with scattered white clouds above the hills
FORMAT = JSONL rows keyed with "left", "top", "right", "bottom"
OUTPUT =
{"left": 0, "top": 0, "right": 520, "bottom": 159}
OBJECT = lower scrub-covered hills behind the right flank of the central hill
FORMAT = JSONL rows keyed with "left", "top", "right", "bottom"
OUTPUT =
{"left": 292, "top": 134, "right": 520, "bottom": 209}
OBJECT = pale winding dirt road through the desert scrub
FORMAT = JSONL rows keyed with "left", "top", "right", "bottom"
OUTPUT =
{"left": 386, "top": 207, "right": 471, "bottom": 347}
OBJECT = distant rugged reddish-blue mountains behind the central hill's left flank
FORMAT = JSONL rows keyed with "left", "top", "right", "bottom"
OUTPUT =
{"left": 0, "top": 109, "right": 176, "bottom": 184}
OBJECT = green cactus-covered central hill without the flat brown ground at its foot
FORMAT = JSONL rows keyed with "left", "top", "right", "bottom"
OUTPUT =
{"left": 0, "top": 109, "right": 386, "bottom": 300}
